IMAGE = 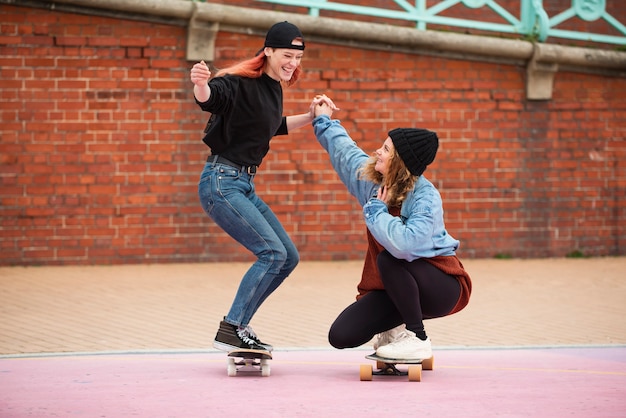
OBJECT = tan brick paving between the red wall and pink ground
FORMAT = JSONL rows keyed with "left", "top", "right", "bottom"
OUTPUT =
{"left": 0, "top": 257, "right": 626, "bottom": 355}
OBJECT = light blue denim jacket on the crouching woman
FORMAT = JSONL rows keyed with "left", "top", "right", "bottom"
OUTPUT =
{"left": 313, "top": 115, "right": 459, "bottom": 261}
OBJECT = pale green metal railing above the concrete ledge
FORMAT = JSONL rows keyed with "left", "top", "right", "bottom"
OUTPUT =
{"left": 250, "top": 0, "right": 626, "bottom": 46}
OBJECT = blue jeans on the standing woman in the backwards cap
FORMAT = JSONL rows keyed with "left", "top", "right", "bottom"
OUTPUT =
{"left": 198, "top": 162, "right": 300, "bottom": 327}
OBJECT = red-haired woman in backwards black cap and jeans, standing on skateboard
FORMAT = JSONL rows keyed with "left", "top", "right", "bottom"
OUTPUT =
{"left": 190, "top": 22, "right": 334, "bottom": 351}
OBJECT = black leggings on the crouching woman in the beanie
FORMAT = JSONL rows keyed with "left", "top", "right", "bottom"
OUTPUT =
{"left": 328, "top": 251, "right": 461, "bottom": 348}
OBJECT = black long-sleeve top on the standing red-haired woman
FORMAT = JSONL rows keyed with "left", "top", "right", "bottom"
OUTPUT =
{"left": 196, "top": 73, "right": 287, "bottom": 166}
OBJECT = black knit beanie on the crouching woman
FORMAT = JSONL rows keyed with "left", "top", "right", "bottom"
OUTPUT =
{"left": 389, "top": 128, "right": 439, "bottom": 176}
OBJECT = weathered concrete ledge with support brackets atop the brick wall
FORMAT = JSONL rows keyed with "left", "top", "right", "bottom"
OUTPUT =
{"left": 12, "top": 0, "right": 626, "bottom": 100}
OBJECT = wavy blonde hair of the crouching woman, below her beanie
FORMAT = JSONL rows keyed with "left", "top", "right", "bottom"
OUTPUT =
{"left": 360, "top": 147, "right": 418, "bottom": 207}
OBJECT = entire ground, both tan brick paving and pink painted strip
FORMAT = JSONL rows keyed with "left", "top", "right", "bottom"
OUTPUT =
{"left": 0, "top": 257, "right": 626, "bottom": 418}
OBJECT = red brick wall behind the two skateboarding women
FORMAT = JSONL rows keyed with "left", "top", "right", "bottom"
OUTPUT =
{"left": 0, "top": 5, "right": 626, "bottom": 265}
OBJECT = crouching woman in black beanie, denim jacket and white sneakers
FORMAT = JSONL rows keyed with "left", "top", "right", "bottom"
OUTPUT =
{"left": 312, "top": 103, "right": 472, "bottom": 360}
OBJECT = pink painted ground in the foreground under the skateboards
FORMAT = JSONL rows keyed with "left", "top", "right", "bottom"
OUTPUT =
{"left": 0, "top": 346, "right": 626, "bottom": 418}
